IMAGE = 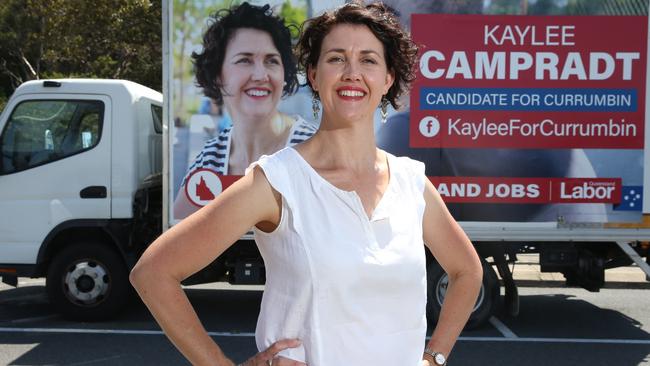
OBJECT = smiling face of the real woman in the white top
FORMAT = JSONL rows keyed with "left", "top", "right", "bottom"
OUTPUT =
{"left": 308, "top": 24, "right": 394, "bottom": 123}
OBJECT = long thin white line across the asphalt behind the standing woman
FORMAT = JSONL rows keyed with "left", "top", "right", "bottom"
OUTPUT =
{"left": 0, "top": 327, "right": 650, "bottom": 345}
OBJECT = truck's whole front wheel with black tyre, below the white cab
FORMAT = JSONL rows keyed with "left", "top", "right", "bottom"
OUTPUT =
{"left": 46, "top": 242, "right": 132, "bottom": 321}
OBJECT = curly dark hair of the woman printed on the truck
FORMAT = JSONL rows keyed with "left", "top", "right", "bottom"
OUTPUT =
{"left": 192, "top": 2, "right": 298, "bottom": 105}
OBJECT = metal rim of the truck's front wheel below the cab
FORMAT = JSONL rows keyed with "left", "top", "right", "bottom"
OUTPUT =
{"left": 63, "top": 260, "right": 111, "bottom": 306}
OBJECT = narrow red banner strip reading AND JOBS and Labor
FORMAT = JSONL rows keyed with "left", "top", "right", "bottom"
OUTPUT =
{"left": 429, "top": 177, "right": 622, "bottom": 204}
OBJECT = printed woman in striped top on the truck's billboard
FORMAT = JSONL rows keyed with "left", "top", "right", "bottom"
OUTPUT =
{"left": 174, "top": 3, "right": 316, "bottom": 218}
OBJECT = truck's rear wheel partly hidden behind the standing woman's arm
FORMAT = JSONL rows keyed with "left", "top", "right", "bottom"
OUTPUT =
{"left": 427, "top": 261, "right": 500, "bottom": 329}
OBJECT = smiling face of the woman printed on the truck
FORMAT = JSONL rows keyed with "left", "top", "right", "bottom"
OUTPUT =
{"left": 220, "top": 28, "right": 284, "bottom": 121}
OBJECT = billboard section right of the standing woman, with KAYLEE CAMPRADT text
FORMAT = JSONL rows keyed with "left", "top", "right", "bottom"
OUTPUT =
{"left": 400, "top": 14, "right": 647, "bottom": 223}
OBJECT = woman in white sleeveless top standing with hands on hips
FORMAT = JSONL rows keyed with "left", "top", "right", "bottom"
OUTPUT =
{"left": 131, "top": 3, "right": 482, "bottom": 366}
